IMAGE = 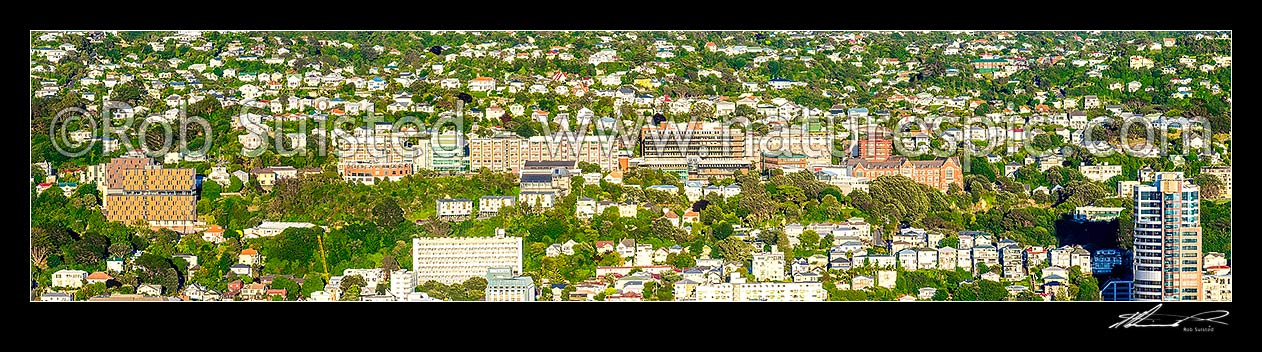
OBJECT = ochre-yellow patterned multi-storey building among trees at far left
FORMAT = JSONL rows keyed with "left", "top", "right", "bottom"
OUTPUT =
{"left": 102, "top": 164, "right": 197, "bottom": 233}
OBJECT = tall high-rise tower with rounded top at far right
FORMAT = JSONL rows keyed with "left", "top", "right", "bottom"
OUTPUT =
{"left": 1133, "top": 173, "right": 1204, "bottom": 300}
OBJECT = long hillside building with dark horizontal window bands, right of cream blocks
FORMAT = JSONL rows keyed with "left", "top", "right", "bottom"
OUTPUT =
{"left": 639, "top": 122, "right": 755, "bottom": 179}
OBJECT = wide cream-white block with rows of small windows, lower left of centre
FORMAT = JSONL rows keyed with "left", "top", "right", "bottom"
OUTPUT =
{"left": 411, "top": 235, "right": 521, "bottom": 284}
